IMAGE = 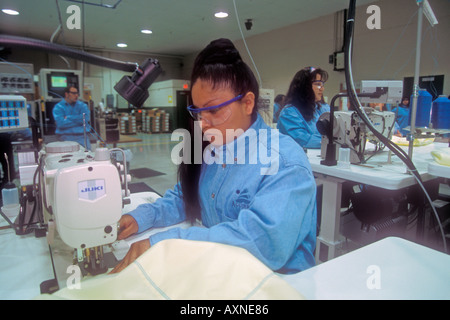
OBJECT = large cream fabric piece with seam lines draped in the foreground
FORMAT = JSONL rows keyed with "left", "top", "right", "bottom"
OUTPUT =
{"left": 38, "top": 239, "right": 304, "bottom": 300}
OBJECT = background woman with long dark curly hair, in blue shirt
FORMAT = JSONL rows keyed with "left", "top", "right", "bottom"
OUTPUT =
{"left": 277, "top": 67, "right": 330, "bottom": 149}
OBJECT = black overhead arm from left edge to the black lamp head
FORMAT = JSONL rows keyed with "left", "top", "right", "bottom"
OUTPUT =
{"left": 0, "top": 34, "right": 137, "bottom": 72}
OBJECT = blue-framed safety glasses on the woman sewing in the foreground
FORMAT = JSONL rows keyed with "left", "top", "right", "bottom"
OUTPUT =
{"left": 187, "top": 94, "right": 243, "bottom": 126}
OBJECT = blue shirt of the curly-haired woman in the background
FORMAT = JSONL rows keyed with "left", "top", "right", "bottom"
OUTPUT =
{"left": 277, "top": 103, "right": 330, "bottom": 149}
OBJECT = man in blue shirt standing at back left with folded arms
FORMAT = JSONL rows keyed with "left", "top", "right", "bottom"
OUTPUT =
{"left": 53, "top": 86, "right": 91, "bottom": 149}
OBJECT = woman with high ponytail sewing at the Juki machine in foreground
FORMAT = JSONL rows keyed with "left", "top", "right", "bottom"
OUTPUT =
{"left": 112, "top": 39, "right": 317, "bottom": 273}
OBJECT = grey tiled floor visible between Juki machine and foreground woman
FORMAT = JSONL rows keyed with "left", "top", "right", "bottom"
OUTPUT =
{"left": 112, "top": 133, "right": 179, "bottom": 195}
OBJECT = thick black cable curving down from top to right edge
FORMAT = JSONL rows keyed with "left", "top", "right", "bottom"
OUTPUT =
{"left": 344, "top": 0, "right": 447, "bottom": 253}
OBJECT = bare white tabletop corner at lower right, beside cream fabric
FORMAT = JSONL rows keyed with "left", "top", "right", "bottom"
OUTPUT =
{"left": 283, "top": 237, "right": 450, "bottom": 300}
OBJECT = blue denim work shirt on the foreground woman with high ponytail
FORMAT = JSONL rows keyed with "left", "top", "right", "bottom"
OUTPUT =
{"left": 129, "top": 116, "right": 317, "bottom": 273}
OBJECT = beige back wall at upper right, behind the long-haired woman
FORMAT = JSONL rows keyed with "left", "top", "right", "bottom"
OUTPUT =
{"left": 184, "top": 0, "right": 450, "bottom": 101}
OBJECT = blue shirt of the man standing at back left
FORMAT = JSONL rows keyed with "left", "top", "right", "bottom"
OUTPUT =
{"left": 53, "top": 99, "right": 91, "bottom": 149}
